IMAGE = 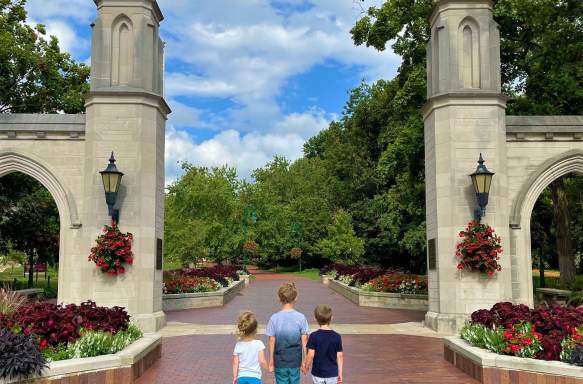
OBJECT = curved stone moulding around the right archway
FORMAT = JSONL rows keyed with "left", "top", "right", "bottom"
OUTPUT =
{"left": 510, "top": 149, "right": 583, "bottom": 228}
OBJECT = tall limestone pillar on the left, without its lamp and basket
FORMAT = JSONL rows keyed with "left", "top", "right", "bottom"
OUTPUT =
{"left": 59, "top": 0, "right": 170, "bottom": 331}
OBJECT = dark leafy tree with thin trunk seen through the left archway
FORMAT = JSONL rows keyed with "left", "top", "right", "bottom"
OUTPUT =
{"left": 0, "top": 173, "right": 60, "bottom": 288}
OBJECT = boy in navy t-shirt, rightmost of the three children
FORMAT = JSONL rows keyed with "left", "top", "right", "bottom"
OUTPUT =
{"left": 302, "top": 305, "right": 344, "bottom": 384}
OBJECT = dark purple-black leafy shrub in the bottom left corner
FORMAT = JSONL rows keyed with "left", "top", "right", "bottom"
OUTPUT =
{"left": 0, "top": 329, "right": 47, "bottom": 379}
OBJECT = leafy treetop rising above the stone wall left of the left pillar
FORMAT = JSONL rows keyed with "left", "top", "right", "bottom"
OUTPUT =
{"left": 0, "top": 0, "right": 89, "bottom": 113}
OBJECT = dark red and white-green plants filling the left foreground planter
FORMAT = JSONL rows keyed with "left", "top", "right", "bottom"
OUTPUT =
{"left": 0, "top": 301, "right": 148, "bottom": 380}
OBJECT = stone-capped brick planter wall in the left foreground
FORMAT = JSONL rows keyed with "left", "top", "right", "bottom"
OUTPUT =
{"left": 0, "top": 334, "right": 162, "bottom": 384}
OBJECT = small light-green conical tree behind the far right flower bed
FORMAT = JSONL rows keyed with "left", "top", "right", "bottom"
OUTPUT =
{"left": 314, "top": 209, "right": 364, "bottom": 265}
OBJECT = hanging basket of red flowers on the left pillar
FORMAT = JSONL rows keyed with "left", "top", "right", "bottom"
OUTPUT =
{"left": 89, "top": 223, "right": 134, "bottom": 276}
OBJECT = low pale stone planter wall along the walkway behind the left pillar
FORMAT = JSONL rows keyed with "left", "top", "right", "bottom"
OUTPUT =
{"left": 162, "top": 280, "right": 246, "bottom": 311}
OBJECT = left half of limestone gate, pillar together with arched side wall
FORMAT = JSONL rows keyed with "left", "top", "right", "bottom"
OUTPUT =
{"left": 0, "top": 0, "right": 170, "bottom": 331}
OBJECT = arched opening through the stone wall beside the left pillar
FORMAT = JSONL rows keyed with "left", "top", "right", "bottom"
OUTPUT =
{"left": 0, "top": 171, "right": 61, "bottom": 299}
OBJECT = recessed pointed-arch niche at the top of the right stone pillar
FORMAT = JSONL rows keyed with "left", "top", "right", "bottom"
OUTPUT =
{"left": 458, "top": 17, "right": 480, "bottom": 88}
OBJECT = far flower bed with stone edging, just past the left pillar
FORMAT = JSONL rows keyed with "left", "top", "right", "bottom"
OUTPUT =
{"left": 162, "top": 266, "right": 245, "bottom": 311}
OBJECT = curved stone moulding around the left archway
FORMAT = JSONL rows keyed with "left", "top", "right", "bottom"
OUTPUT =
{"left": 0, "top": 150, "right": 81, "bottom": 228}
